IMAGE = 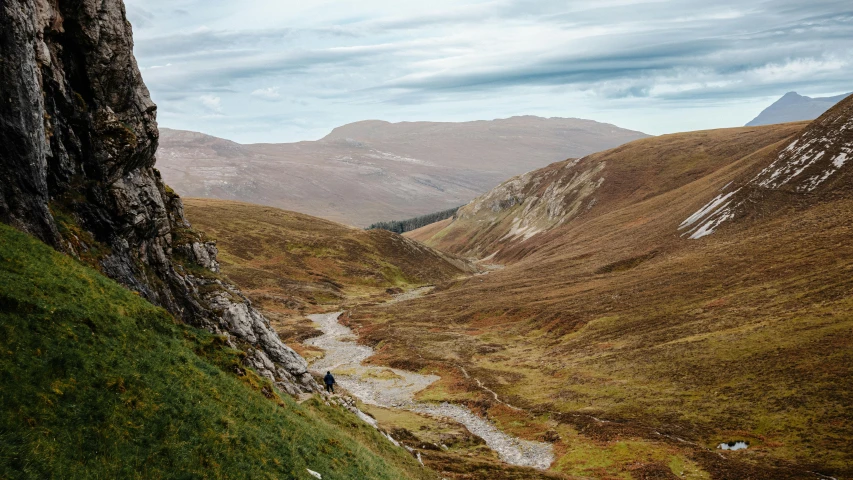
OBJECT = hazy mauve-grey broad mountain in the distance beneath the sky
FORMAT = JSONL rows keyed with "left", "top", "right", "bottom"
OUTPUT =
{"left": 157, "top": 117, "right": 646, "bottom": 227}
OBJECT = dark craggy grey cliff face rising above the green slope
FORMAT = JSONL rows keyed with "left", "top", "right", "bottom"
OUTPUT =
{"left": 0, "top": 0, "right": 317, "bottom": 393}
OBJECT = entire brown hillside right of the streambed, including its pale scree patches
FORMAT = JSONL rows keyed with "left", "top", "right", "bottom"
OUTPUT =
{"left": 351, "top": 108, "right": 853, "bottom": 479}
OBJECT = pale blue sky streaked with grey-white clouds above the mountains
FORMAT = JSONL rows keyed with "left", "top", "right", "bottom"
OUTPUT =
{"left": 126, "top": 0, "right": 853, "bottom": 143}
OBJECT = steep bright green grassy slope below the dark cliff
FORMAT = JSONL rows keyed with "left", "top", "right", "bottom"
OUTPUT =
{"left": 0, "top": 225, "right": 434, "bottom": 479}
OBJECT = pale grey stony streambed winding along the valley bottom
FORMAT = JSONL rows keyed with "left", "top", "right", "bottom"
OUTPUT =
{"left": 306, "top": 312, "right": 554, "bottom": 469}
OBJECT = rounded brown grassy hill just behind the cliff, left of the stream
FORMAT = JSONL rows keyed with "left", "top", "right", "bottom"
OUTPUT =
{"left": 185, "top": 199, "right": 471, "bottom": 353}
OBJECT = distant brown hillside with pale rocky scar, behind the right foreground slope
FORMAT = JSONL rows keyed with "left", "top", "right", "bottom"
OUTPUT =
{"left": 406, "top": 123, "right": 805, "bottom": 262}
